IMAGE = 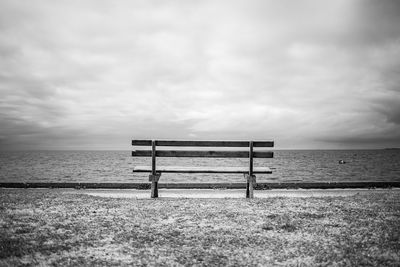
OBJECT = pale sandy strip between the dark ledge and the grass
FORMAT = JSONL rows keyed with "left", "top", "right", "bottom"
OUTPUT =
{"left": 69, "top": 188, "right": 400, "bottom": 199}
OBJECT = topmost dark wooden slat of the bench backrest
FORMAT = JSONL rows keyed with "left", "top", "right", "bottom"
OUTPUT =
{"left": 132, "top": 140, "right": 274, "bottom": 147}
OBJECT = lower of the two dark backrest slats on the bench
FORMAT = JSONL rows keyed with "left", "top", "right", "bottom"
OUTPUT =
{"left": 132, "top": 150, "right": 274, "bottom": 158}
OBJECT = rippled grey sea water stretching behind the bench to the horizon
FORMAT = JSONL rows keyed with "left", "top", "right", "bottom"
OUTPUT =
{"left": 0, "top": 150, "right": 400, "bottom": 183}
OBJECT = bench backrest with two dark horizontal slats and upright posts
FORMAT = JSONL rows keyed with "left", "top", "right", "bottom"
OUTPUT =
{"left": 132, "top": 140, "right": 274, "bottom": 175}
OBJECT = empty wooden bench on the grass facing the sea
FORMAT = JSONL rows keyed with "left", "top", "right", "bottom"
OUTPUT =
{"left": 132, "top": 140, "right": 274, "bottom": 198}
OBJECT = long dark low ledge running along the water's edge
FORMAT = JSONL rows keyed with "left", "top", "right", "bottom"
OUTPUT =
{"left": 0, "top": 181, "right": 400, "bottom": 190}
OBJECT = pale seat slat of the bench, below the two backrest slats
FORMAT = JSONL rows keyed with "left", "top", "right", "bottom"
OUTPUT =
{"left": 133, "top": 166, "right": 272, "bottom": 173}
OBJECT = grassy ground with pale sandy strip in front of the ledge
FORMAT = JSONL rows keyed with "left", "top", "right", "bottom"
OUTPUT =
{"left": 0, "top": 188, "right": 400, "bottom": 266}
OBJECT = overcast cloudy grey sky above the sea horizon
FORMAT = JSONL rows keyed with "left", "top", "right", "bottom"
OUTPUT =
{"left": 0, "top": 0, "right": 400, "bottom": 150}
